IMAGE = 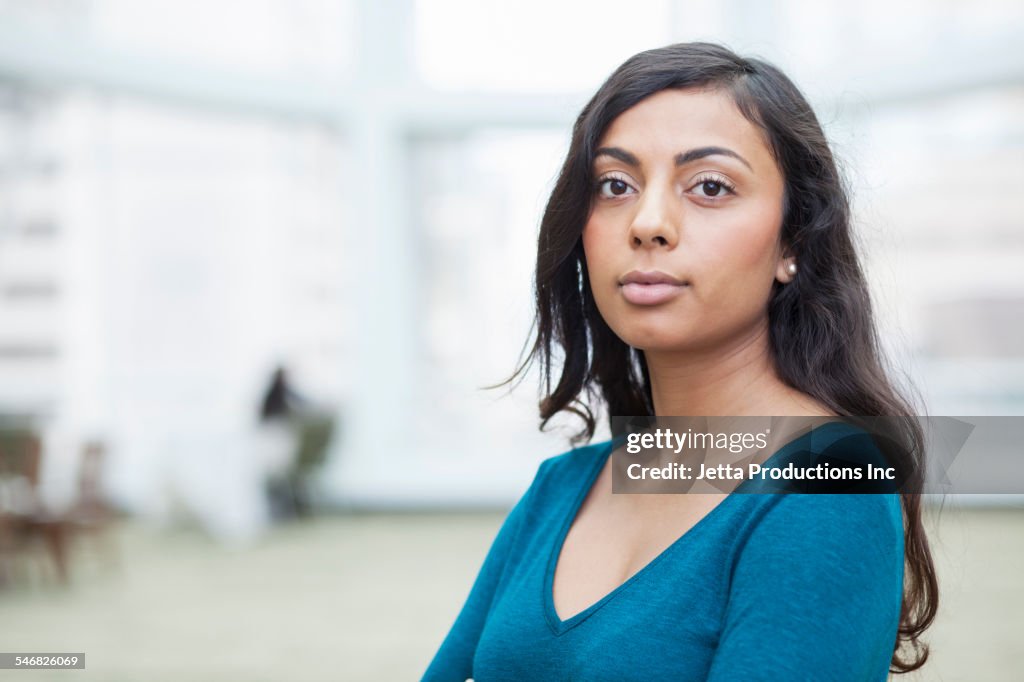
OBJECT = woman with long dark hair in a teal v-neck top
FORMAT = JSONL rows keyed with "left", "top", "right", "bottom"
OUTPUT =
{"left": 424, "top": 43, "right": 938, "bottom": 682}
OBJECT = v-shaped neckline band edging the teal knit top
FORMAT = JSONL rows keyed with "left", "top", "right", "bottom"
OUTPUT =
{"left": 543, "top": 422, "right": 849, "bottom": 637}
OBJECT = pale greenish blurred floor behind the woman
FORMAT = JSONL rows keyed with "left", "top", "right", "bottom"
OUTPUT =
{"left": 0, "top": 507, "right": 1024, "bottom": 682}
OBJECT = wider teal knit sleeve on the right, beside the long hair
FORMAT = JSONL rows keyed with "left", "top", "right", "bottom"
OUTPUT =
{"left": 708, "top": 494, "right": 903, "bottom": 682}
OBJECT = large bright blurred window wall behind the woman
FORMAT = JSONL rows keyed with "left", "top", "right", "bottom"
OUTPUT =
{"left": 0, "top": 0, "right": 1024, "bottom": 503}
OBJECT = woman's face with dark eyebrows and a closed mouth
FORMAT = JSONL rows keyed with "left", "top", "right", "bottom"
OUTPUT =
{"left": 583, "top": 89, "right": 792, "bottom": 351}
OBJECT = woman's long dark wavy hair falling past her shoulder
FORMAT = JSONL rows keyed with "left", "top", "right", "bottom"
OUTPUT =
{"left": 500, "top": 42, "right": 939, "bottom": 673}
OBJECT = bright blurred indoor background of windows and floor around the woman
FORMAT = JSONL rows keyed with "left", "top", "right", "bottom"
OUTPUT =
{"left": 0, "top": 0, "right": 1024, "bottom": 680}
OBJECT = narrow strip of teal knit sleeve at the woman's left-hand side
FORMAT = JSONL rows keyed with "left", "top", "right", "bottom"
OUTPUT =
{"left": 423, "top": 461, "right": 548, "bottom": 682}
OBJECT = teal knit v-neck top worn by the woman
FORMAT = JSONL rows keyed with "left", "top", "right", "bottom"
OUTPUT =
{"left": 423, "top": 422, "right": 903, "bottom": 682}
